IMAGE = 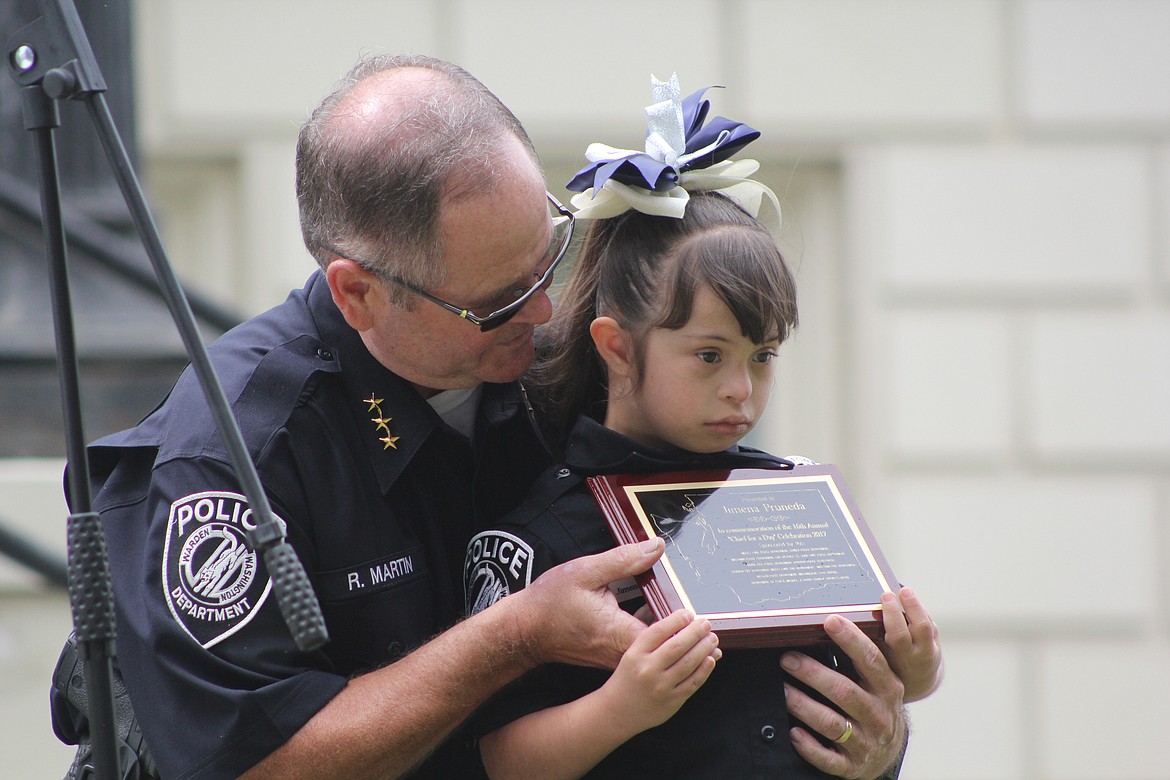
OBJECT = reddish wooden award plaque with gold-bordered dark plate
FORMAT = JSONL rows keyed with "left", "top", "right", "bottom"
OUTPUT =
{"left": 589, "top": 465, "right": 897, "bottom": 647}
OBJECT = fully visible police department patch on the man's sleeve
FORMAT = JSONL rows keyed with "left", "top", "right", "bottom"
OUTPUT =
{"left": 163, "top": 491, "right": 285, "bottom": 648}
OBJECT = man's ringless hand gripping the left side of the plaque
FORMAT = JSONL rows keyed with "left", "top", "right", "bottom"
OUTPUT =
{"left": 505, "top": 539, "right": 666, "bottom": 669}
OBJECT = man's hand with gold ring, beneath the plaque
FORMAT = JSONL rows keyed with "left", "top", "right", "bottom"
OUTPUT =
{"left": 782, "top": 615, "right": 907, "bottom": 780}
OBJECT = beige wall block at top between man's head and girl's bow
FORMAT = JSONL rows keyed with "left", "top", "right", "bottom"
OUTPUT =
{"left": 454, "top": 0, "right": 725, "bottom": 143}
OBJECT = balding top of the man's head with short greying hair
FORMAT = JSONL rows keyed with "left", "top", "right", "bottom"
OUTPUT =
{"left": 297, "top": 51, "right": 539, "bottom": 295}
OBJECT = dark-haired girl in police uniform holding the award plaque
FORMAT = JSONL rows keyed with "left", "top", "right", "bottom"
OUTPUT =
{"left": 466, "top": 76, "right": 940, "bottom": 779}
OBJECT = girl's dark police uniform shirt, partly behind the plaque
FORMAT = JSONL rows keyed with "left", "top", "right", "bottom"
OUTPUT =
{"left": 464, "top": 417, "right": 896, "bottom": 780}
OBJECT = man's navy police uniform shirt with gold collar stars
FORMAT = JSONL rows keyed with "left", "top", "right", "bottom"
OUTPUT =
{"left": 66, "top": 272, "right": 549, "bottom": 779}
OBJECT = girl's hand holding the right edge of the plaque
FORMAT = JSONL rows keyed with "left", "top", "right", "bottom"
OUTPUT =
{"left": 881, "top": 588, "right": 943, "bottom": 702}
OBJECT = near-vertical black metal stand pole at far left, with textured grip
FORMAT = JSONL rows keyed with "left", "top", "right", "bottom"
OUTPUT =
{"left": 21, "top": 79, "right": 122, "bottom": 779}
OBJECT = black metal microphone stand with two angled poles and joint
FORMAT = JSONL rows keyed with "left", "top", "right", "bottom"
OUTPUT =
{"left": 5, "top": 0, "right": 329, "bottom": 780}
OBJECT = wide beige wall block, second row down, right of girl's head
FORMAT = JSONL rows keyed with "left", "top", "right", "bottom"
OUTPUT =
{"left": 873, "top": 145, "right": 1150, "bottom": 297}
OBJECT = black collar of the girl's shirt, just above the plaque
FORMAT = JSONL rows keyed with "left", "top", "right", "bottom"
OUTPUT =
{"left": 565, "top": 415, "right": 792, "bottom": 475}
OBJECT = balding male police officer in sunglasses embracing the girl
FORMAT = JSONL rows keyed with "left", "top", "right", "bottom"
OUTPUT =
{"left": 54, "top": 57, "right": 678, "bottom": 778}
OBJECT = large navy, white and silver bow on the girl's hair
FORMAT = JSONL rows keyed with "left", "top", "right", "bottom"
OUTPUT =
{"left": 566, "top": 75, "right": 780, "bottom": 228}
